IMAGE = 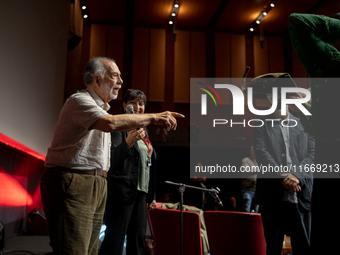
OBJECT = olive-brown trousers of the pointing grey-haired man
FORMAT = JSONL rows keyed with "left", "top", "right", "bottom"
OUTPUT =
{"left": 40, "top": 170, "right": 107, "bottom": 255}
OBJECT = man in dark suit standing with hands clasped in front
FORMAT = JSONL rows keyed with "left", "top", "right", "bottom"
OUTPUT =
{"left": 254, "top": 75, "right": 315, "bottom": 255}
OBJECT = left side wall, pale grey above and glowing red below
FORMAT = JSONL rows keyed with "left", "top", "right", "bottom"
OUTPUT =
{"left": 0, "top": 0, "right": 70, "bottom": 238}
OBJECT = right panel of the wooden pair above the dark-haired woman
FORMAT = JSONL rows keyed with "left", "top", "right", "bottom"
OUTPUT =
{"left": 148, "top": 29, "right": 166, "bottom": 102}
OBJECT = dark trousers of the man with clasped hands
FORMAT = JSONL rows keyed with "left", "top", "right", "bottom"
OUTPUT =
{"left": 261, "top": 202, "right": 311, "bottom": 255}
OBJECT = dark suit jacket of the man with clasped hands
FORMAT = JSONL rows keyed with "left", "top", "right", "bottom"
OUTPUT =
{"left": 254, "top": 114, "right": 315, "bottom": 210}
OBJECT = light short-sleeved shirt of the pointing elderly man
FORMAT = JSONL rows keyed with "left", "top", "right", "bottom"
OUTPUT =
{"left": 45, "top": 88, "right": 111, "bottom": 171}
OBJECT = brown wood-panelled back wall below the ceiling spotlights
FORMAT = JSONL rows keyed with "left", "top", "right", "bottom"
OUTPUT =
{"left": 70, "top": 24, "right": 307, "bottom": 112}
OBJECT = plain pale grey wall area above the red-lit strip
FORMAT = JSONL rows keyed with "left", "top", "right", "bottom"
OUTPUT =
{"left": 0, "top": 0, "right": 70, "bottom": 154}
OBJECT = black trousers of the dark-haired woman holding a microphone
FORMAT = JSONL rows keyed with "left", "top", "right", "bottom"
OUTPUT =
{"left": 99, "top": 191, "right": 147, "bottom": 255}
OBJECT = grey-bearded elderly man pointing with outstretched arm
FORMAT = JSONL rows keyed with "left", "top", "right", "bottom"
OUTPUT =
{"left": 41, "top": 57, "right": 184, "bottom": 255}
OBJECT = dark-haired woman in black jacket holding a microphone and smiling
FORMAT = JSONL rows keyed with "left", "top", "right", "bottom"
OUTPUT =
{"left": 99, "top": 90, "right": 156, "bottom": 255}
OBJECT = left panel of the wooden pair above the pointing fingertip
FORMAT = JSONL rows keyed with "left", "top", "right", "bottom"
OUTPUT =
{"left": 174, "top": 30, "right": 190, "bottom": 103}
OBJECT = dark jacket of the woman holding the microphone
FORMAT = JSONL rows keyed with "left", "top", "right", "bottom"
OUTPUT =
{"left": 107, "top": 132, "right": 156, "bottom": 207}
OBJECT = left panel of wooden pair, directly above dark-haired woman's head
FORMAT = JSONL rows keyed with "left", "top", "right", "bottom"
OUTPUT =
{"left": 132, "top": 27, "right": 150, "bottom": 95}
